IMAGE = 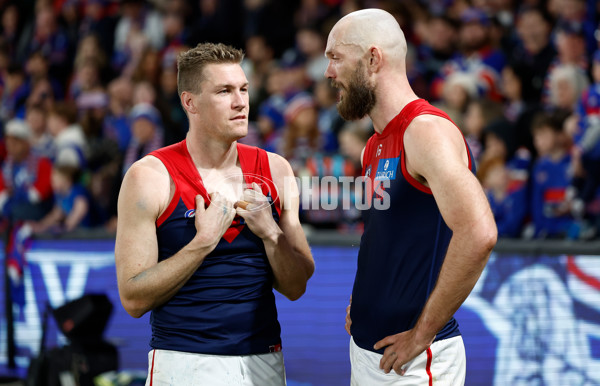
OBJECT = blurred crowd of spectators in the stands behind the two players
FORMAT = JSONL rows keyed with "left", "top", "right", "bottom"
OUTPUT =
{"left": 0, "top": 0, "right": 600, "bottom": 239}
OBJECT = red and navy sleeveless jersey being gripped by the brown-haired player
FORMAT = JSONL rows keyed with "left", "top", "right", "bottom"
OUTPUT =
{"left": 150, "top": 140, "right": 281, "bottom": 355}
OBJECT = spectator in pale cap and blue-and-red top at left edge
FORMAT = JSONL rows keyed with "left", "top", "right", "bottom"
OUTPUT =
{"left": 0, "top": 119, "right": 52, "bottom": 221}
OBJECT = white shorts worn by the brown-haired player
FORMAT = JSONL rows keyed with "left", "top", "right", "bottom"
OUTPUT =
{"left": 146, "top": 350, "right": 286, "bottom": 386}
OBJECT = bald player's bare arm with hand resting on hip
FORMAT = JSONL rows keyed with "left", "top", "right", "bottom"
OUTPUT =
{"left": 375, "top": 116, "right": 497, "bottom": 374}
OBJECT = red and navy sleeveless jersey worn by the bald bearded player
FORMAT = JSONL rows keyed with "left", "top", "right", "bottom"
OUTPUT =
{"left": 350, "top": 99, "right": 475, "bottom": 353}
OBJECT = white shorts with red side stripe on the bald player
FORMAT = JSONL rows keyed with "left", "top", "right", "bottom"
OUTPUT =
{"left": 350, "top": 336, "right": 466, "bottom": 386}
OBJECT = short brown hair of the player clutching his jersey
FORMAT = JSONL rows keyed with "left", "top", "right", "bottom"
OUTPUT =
{"left": 177, "top": 43, "right": 244, "bottom": 96}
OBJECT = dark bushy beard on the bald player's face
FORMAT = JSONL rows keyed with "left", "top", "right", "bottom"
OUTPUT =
{"left": 331, "top": 64, "right": 376, "bottom": 121}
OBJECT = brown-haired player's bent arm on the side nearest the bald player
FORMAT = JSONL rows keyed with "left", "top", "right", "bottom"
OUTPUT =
{"left": 237, "top": 153, "right": 315, "bottom": 300}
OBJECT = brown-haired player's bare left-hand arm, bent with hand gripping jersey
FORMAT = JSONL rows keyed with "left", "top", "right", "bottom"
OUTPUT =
{"left": 115, "top": 157, "right": 235, "bottom": 317}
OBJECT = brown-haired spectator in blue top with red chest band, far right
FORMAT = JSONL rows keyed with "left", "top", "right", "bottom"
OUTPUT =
{"left": 531, "top": 113, "right": 575, "bottom": 238}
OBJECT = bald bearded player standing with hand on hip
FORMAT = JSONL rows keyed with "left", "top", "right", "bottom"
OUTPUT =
{"left": 325, "top": 9, "right": 497, "bottom": 385}
